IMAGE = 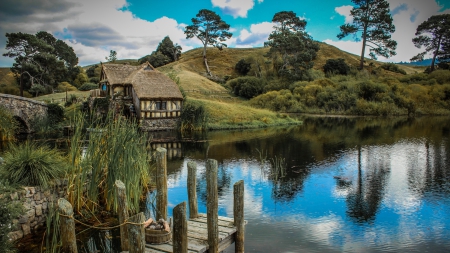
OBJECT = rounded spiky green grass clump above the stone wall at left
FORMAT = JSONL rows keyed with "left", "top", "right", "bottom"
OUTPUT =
{"left": 2, "top": 141, "right": 67, "bottom": 188}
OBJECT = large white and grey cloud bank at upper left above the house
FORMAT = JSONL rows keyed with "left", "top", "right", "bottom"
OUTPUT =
{"left": 0, "top": 0, "right": 188, "bottom": 66}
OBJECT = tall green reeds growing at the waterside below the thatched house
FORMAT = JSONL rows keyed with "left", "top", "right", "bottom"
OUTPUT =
{"left": 68, "top": 114, "right": 151, "bottom": 212}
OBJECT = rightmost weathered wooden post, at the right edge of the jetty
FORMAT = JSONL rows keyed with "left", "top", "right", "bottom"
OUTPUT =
{"left": 233, "top": 180, "right": 245, "bottom": 253}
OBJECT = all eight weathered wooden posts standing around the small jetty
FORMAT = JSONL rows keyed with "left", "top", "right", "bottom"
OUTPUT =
{"left": 58, "top": 148, "right": 245, "bottom": 253}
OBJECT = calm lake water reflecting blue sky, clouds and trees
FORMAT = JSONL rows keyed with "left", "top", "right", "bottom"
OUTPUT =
{"left": 150, "top": 118, "right": 450, "bottom": 252}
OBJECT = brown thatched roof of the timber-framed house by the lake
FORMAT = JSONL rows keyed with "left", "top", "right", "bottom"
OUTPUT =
{"left": 103, "top": 62, "right": 183, "bottom": 99}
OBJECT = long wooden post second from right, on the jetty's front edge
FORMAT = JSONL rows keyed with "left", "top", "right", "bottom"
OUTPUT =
{"left": 206, "top": 159, "right": 219, "bottom": 253}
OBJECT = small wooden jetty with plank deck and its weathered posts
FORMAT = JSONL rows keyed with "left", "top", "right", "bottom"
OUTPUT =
{"left": 58, "top": 148, "right": 246, "bottom": 253}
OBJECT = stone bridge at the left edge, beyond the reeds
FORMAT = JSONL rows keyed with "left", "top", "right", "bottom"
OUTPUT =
{"left": 0, "top": 93, "right": 47, "bottom": 133}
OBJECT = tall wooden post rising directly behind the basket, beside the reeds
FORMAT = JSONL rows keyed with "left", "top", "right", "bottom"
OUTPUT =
{"left": 156, "top": 148, "right": 167, "bottom": 221}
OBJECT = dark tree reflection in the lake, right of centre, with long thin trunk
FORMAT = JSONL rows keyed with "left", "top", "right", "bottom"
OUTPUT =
{"left": 347, "top": 147, "right": 390, "bottom": 223}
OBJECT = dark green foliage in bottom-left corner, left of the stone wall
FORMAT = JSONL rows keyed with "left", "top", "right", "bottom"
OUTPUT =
{"left": 0, "top": 179, "right": 24, "bottom": 253}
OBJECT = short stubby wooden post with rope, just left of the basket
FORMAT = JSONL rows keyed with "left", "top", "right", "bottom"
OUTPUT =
{"left": 127, "top": 212, "right": 145, "bottom": 253}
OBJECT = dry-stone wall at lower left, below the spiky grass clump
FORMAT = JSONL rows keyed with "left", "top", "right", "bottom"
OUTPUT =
{"left": 9, "top": 180, "right": 67, "bottom": 240}
